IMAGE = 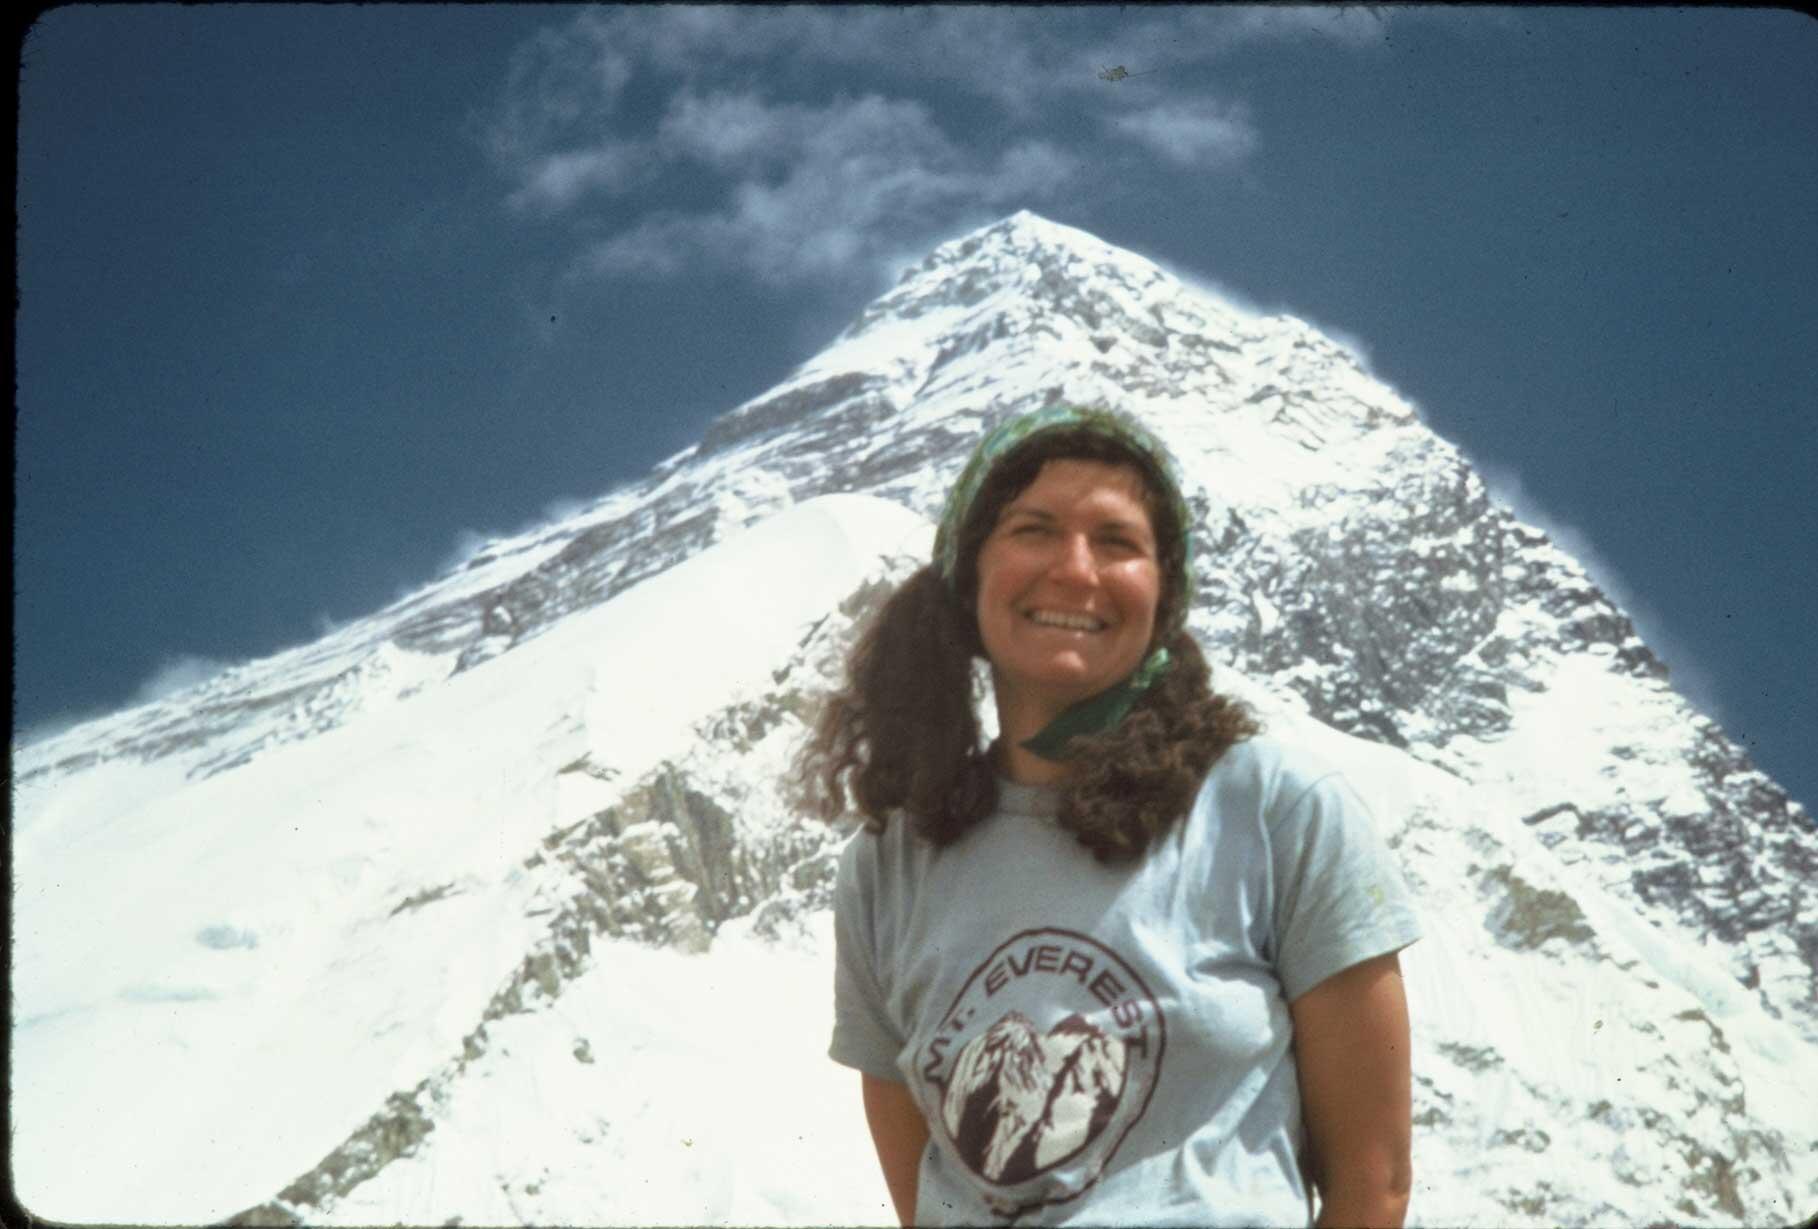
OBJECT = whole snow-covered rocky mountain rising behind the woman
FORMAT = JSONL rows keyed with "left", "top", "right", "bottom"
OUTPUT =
{"left": 11, "top": 213, "right": 1818, "bottom": 1225}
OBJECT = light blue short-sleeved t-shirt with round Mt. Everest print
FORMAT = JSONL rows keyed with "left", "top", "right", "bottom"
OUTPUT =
{"left": 829, "top": 736, "right": 1420, "bottom": 1225}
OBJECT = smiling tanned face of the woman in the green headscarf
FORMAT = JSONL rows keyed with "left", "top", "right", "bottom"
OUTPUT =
{"left": 978, "top": 460, "right": 1162, "bottom": 720}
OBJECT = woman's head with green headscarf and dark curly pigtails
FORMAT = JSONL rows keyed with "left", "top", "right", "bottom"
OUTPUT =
{"left": 805, "top": 405, "right": 1256, "bottom": 860}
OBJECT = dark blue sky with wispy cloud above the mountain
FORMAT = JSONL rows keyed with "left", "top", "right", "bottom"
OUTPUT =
{"left": 15, "top": 5, "right": 1818, "bottom": 804}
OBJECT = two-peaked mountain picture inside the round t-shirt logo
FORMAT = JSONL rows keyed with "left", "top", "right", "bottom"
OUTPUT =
{"left": 942, "top": 1011, "right": 1127, "bottom": 1184}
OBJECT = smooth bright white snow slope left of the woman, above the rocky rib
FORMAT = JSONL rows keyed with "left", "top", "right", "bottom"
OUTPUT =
{"left": 13, "top": 496, "right": 925, "bottom": 1224}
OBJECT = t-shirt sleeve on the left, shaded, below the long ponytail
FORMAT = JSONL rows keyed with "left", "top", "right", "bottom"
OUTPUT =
{"left": 827, "top": 831, "right": 904, "bottom": 1080}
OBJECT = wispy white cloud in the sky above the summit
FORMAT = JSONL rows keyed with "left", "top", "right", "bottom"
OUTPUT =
{"left": 478, "top": 5, "right": 1374, "bottom": 284}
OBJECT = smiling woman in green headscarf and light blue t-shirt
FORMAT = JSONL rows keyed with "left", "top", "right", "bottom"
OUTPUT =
{"left": 807, "top": 405, "right": 1420, "bottom": 1225}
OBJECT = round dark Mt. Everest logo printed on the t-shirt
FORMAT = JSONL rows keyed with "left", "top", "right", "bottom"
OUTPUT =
{"left": 918, "top": 927, "right": 1165, "bottom": 1216}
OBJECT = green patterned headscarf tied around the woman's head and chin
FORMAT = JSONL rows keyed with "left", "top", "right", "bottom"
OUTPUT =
{"left": 934, "top": 405, "right": 1193, "bottom": 760}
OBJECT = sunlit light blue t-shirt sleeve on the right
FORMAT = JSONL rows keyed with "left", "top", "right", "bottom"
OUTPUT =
{"left": 1269, "top": 773, "right": 1420, "bottom": 1002}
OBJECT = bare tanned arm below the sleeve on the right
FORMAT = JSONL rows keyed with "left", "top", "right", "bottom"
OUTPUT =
{"left": 1287, "top": 953, "right": 1413, "bottom": 1229}
